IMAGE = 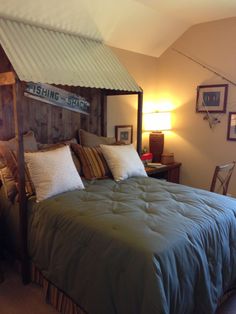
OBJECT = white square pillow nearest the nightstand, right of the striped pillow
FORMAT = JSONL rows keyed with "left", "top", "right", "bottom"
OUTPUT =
{"left": 100, "top": 144, "right": 147, "bottom": 181}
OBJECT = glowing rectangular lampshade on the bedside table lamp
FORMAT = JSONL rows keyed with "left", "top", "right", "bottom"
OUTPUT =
{"left": 143, "top": 111, "right": 171, "bottom": 132}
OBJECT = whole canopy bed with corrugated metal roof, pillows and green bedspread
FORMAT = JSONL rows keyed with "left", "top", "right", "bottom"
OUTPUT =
{"left": 0, "top": 15, "right": 236, "bottom": 314}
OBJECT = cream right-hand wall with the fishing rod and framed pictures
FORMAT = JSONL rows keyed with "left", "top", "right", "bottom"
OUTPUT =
{"left": 156, "top": 18, "right": 236, "bottom": 196}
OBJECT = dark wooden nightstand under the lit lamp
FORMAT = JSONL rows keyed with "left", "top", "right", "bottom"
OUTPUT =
{"left": 145, "top": 162, "right": 181, "bottom": 183}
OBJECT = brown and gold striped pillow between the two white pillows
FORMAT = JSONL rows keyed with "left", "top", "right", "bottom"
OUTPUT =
{"left": 71, "top": 144, "right": 111, "bottom": 179}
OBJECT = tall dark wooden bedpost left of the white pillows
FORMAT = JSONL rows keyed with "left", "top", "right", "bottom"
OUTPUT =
{"left": 12, "top": 80, "right": 30, "bottom": 284}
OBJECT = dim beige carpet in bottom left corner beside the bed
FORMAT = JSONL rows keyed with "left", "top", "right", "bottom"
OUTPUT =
{"left": 0, "top": 267, "right": 58, "bottom": 314}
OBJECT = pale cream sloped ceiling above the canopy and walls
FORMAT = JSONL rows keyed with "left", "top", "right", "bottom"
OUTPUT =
{"left": 0, "top": 0, "right": 236, "bottom": 57}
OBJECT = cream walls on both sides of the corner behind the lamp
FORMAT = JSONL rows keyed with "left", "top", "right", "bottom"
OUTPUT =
{"left": 108, "top": 18, "right": 236, "bottom": 196}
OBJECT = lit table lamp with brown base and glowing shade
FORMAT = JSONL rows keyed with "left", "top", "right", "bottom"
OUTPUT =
{"left": 143, "top": 111, "right": 171, "bottom": 162}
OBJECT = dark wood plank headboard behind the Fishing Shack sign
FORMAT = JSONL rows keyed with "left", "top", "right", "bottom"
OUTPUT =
{"left": 0, "top": 47, "right": 106, "bottom": 143}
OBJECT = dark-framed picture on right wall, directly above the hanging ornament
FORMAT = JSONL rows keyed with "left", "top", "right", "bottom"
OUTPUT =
{"left": 196, "top": 84, "right": 228, "bottom": 113}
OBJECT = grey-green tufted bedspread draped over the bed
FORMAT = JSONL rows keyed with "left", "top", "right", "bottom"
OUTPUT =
{"left": 29, "top": 177, "right": 236, "bottom": 314}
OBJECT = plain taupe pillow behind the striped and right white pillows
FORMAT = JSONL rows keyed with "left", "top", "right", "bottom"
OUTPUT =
{"left": 79, "top": 129, "right": 116, "bottom": 147}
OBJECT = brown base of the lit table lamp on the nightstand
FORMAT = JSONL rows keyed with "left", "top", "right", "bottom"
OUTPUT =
{"left": 149, "top": 132, "right": 164, "bottom": 162}
